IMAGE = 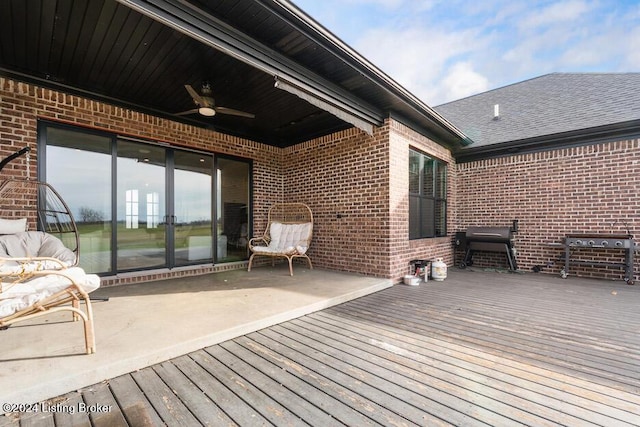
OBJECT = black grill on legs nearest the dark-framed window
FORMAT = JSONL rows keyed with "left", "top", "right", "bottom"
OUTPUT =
{"left": 458, "top": 227, "right": 518, "bottom": 271}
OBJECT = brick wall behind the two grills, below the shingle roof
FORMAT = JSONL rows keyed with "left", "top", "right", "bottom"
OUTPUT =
{"left": 457, "top": 139, "right": 640, "bottom": 280}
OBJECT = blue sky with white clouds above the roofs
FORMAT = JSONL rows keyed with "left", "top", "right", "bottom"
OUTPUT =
{"left": 292, "top": 0, "right": 640, "bottom": 107}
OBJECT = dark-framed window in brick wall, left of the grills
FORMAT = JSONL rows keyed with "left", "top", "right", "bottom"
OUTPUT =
{"left": 409, "top": 149, "right": 447, "bottom": 239}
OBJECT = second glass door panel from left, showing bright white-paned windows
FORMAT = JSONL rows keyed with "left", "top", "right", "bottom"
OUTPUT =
{"left": 116, "top": 140, "right": 167, "bottom": 270}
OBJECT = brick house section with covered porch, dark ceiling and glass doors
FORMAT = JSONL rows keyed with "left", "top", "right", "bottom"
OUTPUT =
{"left": 0, "top": 0, "right": 469, "bottom": 284}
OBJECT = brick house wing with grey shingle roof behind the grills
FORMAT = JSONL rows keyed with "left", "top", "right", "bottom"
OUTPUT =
{"left": 435, "top": 73, "right": 640, "bottom": 280}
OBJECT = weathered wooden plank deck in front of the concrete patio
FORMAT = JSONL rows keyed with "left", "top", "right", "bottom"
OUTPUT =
{"left": 0, "top": 271, "right": 640, "bottom": 427}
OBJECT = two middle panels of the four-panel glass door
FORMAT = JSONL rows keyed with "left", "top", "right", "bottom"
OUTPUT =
{"left": 117, "top": 140, "right": 218, "bottom": 270}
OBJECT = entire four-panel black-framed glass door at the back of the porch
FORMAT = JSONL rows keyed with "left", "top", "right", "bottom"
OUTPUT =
{"left": 38, "top": 125, "right": 251, "bottom": 274}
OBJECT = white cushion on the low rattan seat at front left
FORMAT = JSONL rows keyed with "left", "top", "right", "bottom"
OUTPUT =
{"left": 0, "top": 267, "right": 100, "bottom": 318}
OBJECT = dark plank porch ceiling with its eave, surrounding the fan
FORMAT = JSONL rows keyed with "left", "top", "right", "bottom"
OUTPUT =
{"left": 0, "top": 0, "right": 464, "bottom": 147}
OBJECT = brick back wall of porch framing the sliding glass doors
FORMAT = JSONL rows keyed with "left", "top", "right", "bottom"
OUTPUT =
{"left": 0, "top": 77, "right": 283, "bottom": 284}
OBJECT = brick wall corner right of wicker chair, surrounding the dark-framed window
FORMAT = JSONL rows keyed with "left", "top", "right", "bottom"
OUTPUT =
{"left": 283, "top": 119, "right": 456, "bottom": 282}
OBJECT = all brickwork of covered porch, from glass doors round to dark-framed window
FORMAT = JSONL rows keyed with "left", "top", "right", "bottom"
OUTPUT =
{"left": 0, "top": 78, "right": 464, "bottom": 283}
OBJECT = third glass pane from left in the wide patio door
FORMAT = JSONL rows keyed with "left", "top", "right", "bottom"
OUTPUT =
{"left": 170, "top": 151, "right": 213, "bottom": 265}
